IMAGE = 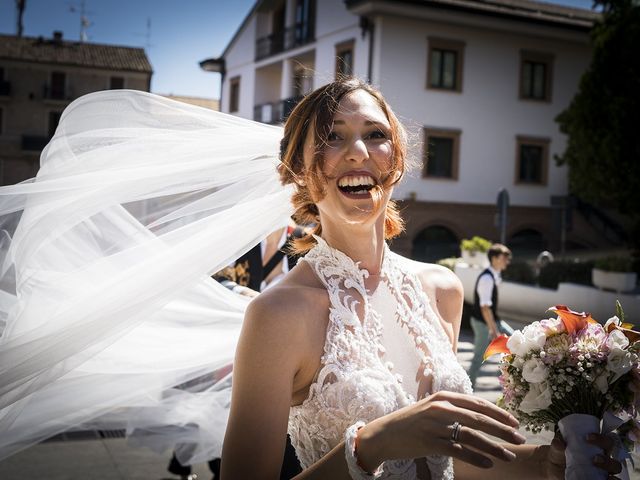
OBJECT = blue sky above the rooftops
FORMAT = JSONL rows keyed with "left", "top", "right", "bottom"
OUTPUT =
{"left": 0, "top": 0, "right": 592, "bottom": 98}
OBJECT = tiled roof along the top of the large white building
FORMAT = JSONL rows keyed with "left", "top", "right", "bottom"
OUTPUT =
{"left": 345, "top": 0, "right": 600, "bottom": 29}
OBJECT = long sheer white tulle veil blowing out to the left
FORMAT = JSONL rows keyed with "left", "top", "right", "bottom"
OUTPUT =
{"left": 0, "top": 90, "right": 292, "bottom": 462}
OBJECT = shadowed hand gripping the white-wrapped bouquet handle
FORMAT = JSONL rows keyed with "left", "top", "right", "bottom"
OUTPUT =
{"left": 542, "top": 433, "right": 622, "bottom": 480}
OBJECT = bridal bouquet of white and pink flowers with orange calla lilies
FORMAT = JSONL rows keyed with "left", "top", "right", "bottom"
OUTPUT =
{"left": 484, "top": 303, "right": 640, "bottom": 479}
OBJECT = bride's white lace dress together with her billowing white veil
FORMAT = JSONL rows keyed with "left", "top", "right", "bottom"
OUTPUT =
{"left": 0, "top": 90, "right": 470, "bottom": 478}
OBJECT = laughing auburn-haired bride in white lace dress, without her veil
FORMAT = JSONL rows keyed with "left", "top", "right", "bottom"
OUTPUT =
{"left": 222, "top": 80, "right": 619, "bottom": 479}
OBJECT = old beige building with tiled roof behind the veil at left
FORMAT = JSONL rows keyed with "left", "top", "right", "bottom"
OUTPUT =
{"left": 0, "top": 32, "right": 153, "bottom": 185}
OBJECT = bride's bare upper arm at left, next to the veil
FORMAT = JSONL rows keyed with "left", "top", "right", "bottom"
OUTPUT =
{"left": 221, "top": 289, "right": 305, "bottom": 480}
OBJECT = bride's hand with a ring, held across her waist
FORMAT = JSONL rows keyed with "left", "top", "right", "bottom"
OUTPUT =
{"left": 357, "top": 392, "right": 525, "bottom": 471}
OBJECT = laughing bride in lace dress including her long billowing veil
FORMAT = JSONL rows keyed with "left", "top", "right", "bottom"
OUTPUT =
{"left": 0, "top": 80, "right": 621, "bottom": 479}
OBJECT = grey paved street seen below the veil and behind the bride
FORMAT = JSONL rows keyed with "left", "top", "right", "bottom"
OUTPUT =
{"left": 0, "top": 332, "right": 640, "bottom": 480}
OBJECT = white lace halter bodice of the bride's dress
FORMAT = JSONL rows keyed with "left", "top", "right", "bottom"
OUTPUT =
{"left": 288, "top": 238, "right": 471, "bottom": 480}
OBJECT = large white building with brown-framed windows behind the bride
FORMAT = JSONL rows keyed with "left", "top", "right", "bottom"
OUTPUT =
{"left": 202, "top": 0, "right": 607, "bottom": 258}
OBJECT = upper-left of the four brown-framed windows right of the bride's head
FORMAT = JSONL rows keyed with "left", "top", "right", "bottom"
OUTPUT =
{"left": 427, "top": 37, "right": 464, "bottom": 92}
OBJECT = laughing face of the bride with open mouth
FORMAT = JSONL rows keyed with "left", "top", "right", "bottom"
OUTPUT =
{"left": 304, "top": 90, "right": 393, "bottom": 229}
